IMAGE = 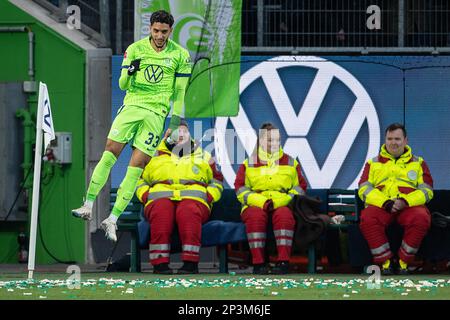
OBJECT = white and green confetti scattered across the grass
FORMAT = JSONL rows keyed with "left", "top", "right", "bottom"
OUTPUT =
{"left": 0, "top": 276, "right": 450, "bottom": 299}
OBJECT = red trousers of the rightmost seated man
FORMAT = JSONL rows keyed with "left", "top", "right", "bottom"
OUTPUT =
{"left": 359, "top": 206, "right": 431, "bottom": 264}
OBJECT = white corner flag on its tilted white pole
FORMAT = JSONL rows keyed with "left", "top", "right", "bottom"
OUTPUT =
{"left": 28, "top": 82, "right": 55, "bottom": 279}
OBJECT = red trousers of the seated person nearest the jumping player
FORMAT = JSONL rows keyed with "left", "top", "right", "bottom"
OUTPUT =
{"left": 145, "top": 198, "right": 210, "bottom": 265}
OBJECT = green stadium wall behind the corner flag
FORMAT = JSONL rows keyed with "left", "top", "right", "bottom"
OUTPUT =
{"left": 0, "top": 1, "right": 86, "bottom": 264}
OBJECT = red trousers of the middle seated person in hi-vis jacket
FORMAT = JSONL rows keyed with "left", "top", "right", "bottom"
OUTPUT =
{"left": 242, "top": 207, "right": 295, "bottom": 264}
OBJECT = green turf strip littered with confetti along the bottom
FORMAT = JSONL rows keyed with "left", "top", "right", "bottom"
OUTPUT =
{"left": 0, "top": 273, "right": 450, "bottom": 300}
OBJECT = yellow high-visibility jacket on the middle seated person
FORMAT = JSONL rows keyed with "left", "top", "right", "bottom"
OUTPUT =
{"left": 234, "top": 147, "right": 306, "bottom": 212}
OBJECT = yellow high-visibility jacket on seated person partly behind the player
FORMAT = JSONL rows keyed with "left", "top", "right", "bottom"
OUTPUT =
{"left": 136, "top": 140, "right": 223, "bottom": 208}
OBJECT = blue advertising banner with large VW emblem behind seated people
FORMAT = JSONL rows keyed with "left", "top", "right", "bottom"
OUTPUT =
{"left": 112, "top": 56, "right": 450, "bottom": 189}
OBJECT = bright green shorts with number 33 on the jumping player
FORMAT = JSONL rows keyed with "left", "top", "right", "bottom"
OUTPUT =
{"left": 108, "top": 105, "right": 166, "bottom": 157}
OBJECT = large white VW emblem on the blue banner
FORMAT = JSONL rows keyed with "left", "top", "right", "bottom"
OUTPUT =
{"left": 216, "top": 56, "right": 380, "bottom": 188}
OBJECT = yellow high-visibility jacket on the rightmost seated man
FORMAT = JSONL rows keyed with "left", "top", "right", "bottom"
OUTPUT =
{"left": 358, "top": 144, "right": 433, "bottom": 208}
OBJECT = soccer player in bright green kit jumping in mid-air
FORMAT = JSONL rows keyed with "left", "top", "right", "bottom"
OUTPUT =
{"left": 72, "top": 10, "right": 191, "bottom": 241}
